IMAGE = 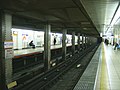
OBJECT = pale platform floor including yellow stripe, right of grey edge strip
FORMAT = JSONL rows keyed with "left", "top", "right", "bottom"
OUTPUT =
{"left": 95, "top": 43, "right": 120, "bottom": 90}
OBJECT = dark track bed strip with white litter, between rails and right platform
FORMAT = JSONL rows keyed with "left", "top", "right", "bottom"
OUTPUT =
{"left": 49, "top": 45, "right": 96, "bottom": 90}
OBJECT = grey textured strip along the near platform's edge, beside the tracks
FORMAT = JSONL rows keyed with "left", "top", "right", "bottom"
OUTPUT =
{"left": 73, "top": 45, "right": 101, "bottom": 90}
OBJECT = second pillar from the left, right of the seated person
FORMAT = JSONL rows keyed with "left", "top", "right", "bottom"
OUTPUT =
{"left": 44, "top": 24, "right": 51, "bottom": 71}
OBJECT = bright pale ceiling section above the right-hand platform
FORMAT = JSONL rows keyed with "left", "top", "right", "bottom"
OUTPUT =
{"left": 81, "top": 0, "right": 119, "bottom": 32}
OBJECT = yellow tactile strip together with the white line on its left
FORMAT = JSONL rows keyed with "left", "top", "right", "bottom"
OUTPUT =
{"left": 94, "top": 43, "right": 111, "bottom": 90}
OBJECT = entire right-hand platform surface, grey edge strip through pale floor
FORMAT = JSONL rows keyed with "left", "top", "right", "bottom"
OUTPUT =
{"left": 74, "top": 43, "right": 120, "bottom": 90}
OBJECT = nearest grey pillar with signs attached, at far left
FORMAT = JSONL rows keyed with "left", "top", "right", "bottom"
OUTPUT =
{"left": 0, "top": 11, "right": 14, "bottom": 90}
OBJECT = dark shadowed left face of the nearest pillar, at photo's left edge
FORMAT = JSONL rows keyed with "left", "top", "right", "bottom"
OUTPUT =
{"left": 0, "top": 11, "right": 6, "bottom": 90}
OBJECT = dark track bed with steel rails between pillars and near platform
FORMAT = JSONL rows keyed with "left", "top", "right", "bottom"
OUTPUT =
{"left": 13, "top": 45, "right": 97, "bottom": 90}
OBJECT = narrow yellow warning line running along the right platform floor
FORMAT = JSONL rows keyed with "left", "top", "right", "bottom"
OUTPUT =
{"left": 100, "top": 45, "right": 109, "bottom": 90}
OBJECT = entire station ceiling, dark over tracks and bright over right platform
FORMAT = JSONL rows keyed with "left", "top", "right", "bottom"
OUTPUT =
{"left": 0, "top": 0, "right": 119, "bottom": 37}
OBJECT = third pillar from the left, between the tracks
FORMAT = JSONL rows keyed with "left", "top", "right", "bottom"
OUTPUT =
{"left": 62, "top": 29, "right": 67, "bottom": 60}
